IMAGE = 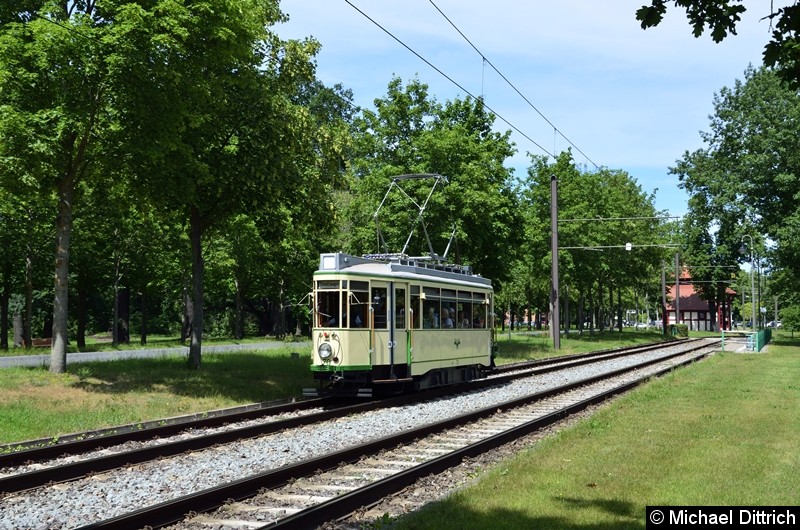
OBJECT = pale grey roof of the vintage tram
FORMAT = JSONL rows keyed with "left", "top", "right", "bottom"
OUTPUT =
{"left": 317, "top": 252, "right": 492, "bottom": 287}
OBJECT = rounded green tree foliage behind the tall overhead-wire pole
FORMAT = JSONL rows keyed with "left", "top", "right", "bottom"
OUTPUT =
{"left": 521, "top": 151, "right": 669, "bottom": 330}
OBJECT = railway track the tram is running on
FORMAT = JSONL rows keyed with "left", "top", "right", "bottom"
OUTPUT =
{"left": 0, "top": 336, "right": 688, "bottom": 472}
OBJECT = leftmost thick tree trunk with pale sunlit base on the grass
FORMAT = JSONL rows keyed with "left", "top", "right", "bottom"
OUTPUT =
{"left": 50, "top": 177, "right": 73, "bottom": 374}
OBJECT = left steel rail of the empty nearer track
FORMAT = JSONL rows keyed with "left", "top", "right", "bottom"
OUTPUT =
{"left": 73, "top": 344, "right": 709, "bottom": 530}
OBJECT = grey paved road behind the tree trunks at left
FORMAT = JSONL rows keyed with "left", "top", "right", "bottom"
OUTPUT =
{"left": 0, "top": 341, "right": 304, "bottom": 368}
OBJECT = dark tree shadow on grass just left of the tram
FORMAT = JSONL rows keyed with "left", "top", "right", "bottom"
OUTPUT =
{"left": 68, "top": 349, "right": 314, "bottom": 402}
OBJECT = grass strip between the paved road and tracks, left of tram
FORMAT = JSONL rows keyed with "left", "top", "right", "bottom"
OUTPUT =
{"left": 0, "top": 343, "right": 314, "bottom": 443}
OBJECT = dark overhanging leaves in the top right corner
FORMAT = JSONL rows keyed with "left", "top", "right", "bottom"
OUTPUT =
{"left": 636, "top": 0, "right": 800, "bottom": 88}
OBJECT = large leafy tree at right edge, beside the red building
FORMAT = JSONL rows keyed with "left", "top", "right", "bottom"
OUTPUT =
{"left": 670, "top": 68, "right": 800, "bottom": 299}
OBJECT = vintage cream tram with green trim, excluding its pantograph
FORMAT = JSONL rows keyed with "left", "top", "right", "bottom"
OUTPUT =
{"left": 311, "top": 253, "right": 494, "bottom": 396}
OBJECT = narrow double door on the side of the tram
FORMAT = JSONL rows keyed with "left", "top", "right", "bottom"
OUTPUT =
{"left": 370, "top": 281, "right": 411, "bottom": 382}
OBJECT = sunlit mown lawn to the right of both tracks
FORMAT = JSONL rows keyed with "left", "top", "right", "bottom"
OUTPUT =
{"left": 396, "top": 334, "right": 800, "bottom": 530}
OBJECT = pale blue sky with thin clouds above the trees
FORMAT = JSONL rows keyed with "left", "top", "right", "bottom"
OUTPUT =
{"left": 274, "top": 0, "right": 770, "bottom": 215}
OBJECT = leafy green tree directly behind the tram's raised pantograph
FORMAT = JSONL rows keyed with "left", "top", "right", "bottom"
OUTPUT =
{"left": 345, "top": 78, "right": 519, "bottom": 280}
